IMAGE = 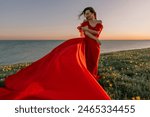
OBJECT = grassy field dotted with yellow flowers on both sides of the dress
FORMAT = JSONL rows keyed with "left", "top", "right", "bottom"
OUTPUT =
{"left": 0, "top": 48, "right": 150, "bottom": 100}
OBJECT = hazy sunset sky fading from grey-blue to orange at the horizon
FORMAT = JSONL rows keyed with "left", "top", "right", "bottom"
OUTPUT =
{"left": 0, "top": 0, "right": 150, "bottom": 40}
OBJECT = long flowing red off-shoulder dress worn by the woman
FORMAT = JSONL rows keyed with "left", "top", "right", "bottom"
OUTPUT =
{"left": 0, "top": 21, "right": 110, "bottom": 100}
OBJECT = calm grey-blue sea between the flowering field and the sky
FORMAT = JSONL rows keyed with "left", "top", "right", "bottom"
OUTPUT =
{"left": 0, "top": 40, "right": 150, "bottom": 65}
